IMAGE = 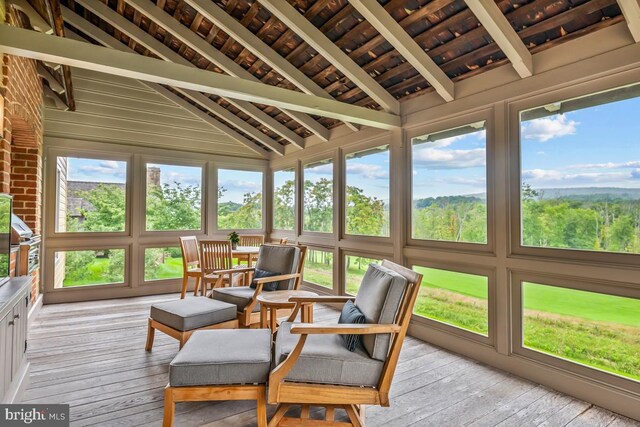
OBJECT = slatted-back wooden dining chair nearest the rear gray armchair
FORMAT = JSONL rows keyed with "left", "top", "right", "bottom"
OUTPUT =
{"left": 200, "top": 240, "right": 248, "bottom": 295}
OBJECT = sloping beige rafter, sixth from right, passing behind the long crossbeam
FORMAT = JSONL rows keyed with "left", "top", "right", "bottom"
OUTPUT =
{"left": 127, "top": 0, "right": 304, "bottom": 148}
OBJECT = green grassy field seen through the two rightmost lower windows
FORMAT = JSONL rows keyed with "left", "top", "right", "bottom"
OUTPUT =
{"left": 414, "top": 267, "right": 640, "bottom": 379}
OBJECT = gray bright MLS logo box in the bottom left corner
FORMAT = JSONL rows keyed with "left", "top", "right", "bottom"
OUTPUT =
{"left": 0, "top": 405, "right": 69, "bottom": 427}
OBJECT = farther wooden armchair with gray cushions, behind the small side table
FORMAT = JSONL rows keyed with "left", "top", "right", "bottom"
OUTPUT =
{"left": 210, "top": 245, "right": 307, "bottom": 327}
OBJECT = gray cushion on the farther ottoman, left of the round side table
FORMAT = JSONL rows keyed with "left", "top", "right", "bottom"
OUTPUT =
{"left": 151, "top": 297, "right": 237, "bottom": 331}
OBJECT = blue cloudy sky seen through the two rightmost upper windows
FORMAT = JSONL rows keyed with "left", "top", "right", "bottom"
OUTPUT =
{"left": 413, "top": 93, "right": 640, "bottom": 198}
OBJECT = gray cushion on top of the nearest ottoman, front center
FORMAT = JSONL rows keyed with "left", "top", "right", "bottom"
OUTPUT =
{"left": 169, "top": 329, "right": 271, "bottom": 387}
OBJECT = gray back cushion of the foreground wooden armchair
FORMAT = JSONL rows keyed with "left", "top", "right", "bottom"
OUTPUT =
{"left": 356, "top": 264, "right": 408, "bottom": 361}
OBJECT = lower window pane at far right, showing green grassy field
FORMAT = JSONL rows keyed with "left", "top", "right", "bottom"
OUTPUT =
{"left": 522, "top": 282, "right": 640, "bottom": 380}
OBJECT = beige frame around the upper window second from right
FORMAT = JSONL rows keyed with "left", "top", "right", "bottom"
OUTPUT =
{"left": 404, "top": 112, "right": 497, "bottom": 255}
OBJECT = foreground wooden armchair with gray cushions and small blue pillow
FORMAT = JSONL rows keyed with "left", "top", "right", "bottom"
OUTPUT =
{"left": 268, "top": 260, "right": 422, "bottom": 427}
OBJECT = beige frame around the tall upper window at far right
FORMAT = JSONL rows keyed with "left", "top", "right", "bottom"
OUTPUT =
{"left": 507, "top": 81, "right": 640, "bottom": 268}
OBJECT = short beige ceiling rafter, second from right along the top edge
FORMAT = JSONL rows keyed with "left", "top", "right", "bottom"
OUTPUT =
{"left": 465, "top": 0, "right": 533, "bottom": 78}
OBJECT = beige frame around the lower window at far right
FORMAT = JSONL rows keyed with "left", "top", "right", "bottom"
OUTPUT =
{"left": 509, "top": 270, "right": 640, "bottom": 393}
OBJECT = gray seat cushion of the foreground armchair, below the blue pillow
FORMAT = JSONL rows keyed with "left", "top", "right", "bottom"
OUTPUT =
{"left": 274, "top": 322, "right": 384, "bottom": 387}
